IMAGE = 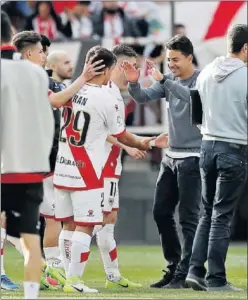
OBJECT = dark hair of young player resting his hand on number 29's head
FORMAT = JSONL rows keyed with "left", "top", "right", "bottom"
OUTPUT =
{"left": 13, "top": 31, "right": 41, "bottom": 52}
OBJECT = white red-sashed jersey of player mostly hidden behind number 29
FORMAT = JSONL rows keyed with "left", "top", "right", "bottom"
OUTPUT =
{"left": 103, "top": 81, "right": 125, "bottom": 178}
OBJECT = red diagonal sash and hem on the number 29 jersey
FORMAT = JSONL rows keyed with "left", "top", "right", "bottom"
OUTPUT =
{"left": 55, "top": 101, "right": 103, "bottom": 191}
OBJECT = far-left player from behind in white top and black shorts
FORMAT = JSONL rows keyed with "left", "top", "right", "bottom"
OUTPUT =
{"left": 0, "top": 12, "right": 54, "bottom": 299}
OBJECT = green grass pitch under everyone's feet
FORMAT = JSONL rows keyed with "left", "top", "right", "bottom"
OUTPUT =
{"left": 1, "top": 244, "right": 247, "bottom": 299}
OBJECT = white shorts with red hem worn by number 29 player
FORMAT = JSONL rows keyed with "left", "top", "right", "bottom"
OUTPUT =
{"left": 54, "top": 188, "right": 104, "bottom": 226}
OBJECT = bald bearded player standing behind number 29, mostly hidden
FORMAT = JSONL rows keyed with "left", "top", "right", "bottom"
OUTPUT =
{"left": 40, "top": 51, "right": 73, "bottom": 285}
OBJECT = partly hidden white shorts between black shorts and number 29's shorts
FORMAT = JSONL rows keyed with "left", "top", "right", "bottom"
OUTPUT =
{"left": 40, "top": 176, "right": 55, "bottom": 219}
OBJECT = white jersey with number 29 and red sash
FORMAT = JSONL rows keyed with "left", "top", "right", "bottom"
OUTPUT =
{"left": 54, "top": 84, "right": 125, "bottom": 190}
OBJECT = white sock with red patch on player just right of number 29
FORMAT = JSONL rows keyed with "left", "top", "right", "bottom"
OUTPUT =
{"left": 96, "top": 224, "right": 121, "bottom": 282}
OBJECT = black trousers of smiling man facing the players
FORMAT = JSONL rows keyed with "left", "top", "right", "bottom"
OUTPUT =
{"left": 153, "top": 155, "right": 201, "bottom": 277}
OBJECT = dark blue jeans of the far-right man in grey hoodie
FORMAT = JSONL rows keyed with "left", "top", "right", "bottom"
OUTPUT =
{"left": 189, "top": 141, "right": 247, "bottom": 287}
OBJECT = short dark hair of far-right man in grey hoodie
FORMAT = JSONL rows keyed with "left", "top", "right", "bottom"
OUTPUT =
{"left": 227, "top": 24, "right": 248, "bottom": 54}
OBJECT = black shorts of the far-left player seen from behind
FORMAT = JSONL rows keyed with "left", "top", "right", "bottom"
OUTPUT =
{"left": 1, "top": 183, "right": 43, "bottom": 238}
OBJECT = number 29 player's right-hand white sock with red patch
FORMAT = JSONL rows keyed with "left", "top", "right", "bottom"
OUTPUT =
{"left": 68, "top": 231, "right": 91, "bottom": 277}
